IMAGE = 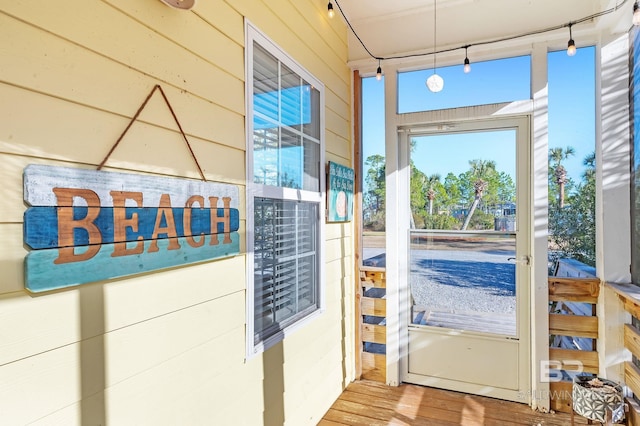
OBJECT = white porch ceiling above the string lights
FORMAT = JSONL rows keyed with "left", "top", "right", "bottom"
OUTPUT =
{"left": 334, "top": 0, "right": 633, "bottom": 64}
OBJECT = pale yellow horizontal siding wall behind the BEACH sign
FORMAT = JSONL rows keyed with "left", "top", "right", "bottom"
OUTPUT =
{"left": 0, "top": 0, "right": 354, "bottom": 425}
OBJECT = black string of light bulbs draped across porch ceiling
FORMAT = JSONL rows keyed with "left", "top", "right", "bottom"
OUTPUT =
{"left": 327, "top": 0, "right": 628, "bottom": 80}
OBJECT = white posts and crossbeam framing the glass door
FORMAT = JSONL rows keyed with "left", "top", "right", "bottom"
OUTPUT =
{"left": 383, "top": 54, "right": 550, "bottom": 412}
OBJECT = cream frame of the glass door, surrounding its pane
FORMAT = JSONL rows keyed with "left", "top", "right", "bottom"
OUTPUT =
{"left": 397, "top": 115, "right": 533, "bottom": 404}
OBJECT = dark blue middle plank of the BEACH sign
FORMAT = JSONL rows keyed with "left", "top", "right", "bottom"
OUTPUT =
{"left": 23, "top": 207, "right": 240, "bottom": 249}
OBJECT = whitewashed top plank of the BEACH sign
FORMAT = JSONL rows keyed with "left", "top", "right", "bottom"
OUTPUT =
{"left": 23, "top": 164, "right": 240, "bottom": 209}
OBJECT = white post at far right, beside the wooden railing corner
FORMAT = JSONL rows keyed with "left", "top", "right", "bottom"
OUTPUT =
{"left": 596, "top": 33, "right": 631, "bottom": 382}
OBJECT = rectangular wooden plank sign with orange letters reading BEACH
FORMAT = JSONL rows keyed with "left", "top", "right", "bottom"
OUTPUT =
{"left": 24, "top": 165, "right": 240, "bottom": 293}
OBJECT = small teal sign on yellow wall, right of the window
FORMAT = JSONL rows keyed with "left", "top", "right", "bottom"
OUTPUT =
{"left": 327, "top": 161, "right": 354, "bottom": 222}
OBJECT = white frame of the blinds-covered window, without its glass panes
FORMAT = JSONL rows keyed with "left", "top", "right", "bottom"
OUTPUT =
{"left": 245, "top": 19, "right": 326, "bottom": 359}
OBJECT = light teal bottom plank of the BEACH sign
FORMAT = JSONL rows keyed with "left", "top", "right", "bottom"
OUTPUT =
{"left": 25, "top": 232, "right": 240, "bottom": 293}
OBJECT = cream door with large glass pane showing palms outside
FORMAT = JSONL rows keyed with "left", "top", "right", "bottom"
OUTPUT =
{"left": 403, "top": 117, "right": 531, "bottom": 403}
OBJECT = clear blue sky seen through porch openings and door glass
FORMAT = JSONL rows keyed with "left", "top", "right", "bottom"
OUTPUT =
{"left": 363, "top": 47, "right": 595, "bottom": 186}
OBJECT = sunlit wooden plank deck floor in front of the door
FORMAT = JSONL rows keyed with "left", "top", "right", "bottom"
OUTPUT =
{"left": 319, "top": 381, "right": 587, "bottom": 426}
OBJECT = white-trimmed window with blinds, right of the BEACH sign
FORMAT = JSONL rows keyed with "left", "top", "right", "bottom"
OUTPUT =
{"left": 246, "top": 23, "right": 325, "bottom": 356}
